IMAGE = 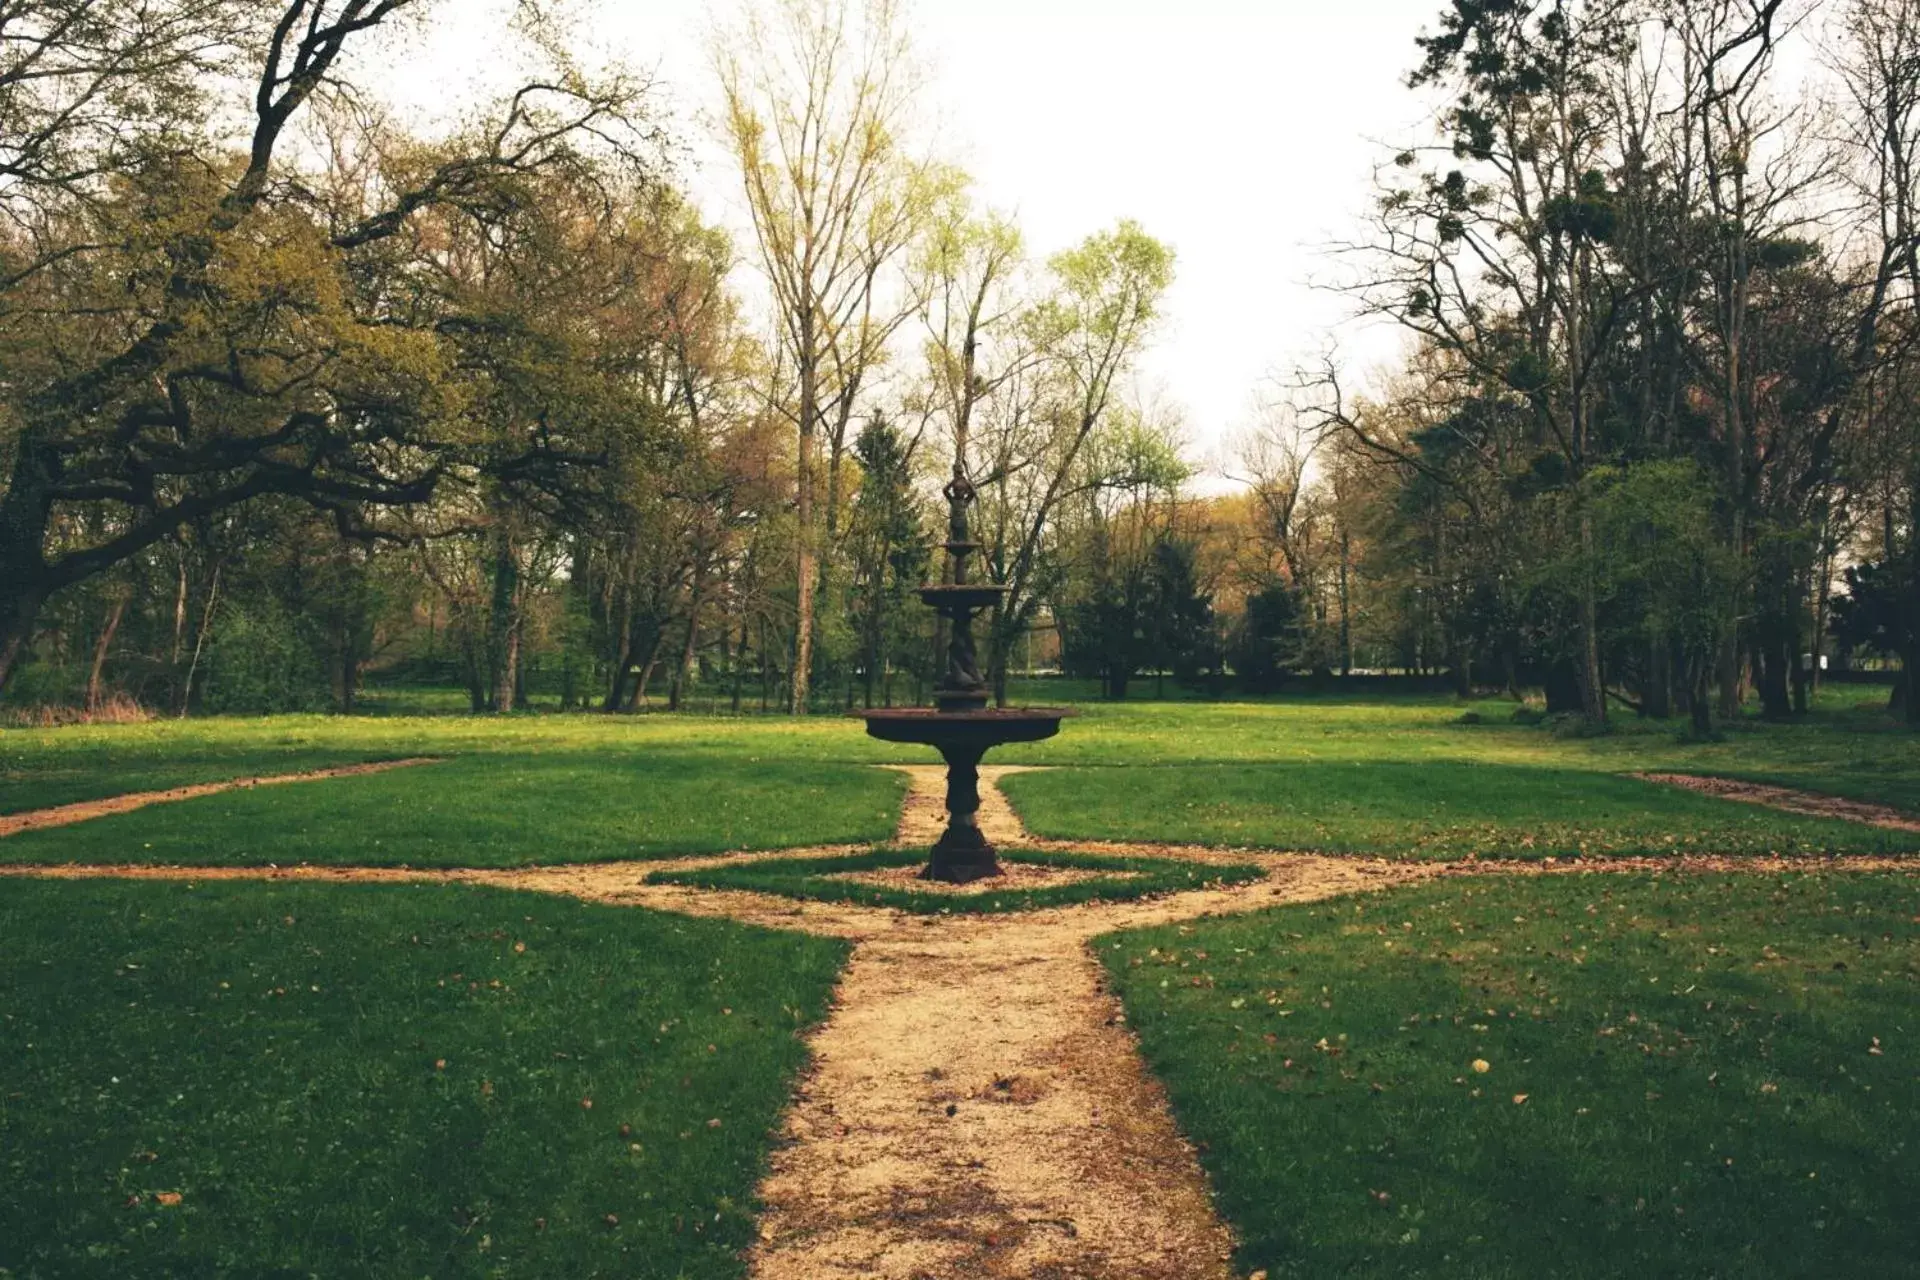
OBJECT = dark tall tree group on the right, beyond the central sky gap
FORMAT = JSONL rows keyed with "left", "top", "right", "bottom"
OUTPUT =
{"left": 1250, "top": 0, "right": 1920, "bottom": 731}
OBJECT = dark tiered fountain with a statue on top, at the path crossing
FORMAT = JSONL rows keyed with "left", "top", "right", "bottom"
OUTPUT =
{"left": 860, "top": 460, "right": 1071, "bottom": 885}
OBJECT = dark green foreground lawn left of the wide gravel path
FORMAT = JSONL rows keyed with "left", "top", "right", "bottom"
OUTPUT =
{"left": 0, "top": 881, "right": 845, "bottom": 1280}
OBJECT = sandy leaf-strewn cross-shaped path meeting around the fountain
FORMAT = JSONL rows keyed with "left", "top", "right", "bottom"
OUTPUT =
{"left": 0, "top": 766, "right": 1914, "bottom": 1280}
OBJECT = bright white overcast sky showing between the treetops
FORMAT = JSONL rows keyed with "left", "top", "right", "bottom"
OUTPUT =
{"left": 409, "top": 0, "right": 1440, "bottom": 468}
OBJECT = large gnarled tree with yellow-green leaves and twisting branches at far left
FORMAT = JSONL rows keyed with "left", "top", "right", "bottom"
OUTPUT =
{"left": 0, "top": 0, "right": 639, "bottom": 687}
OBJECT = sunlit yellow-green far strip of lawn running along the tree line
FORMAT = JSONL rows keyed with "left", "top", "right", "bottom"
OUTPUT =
{"left": 15, "top": 681, "right": 1920, "bottom": 812}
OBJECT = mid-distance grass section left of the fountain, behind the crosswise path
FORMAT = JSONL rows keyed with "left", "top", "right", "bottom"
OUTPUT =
{"left": 0, "top": 752, "right": 906, "bottom": 867}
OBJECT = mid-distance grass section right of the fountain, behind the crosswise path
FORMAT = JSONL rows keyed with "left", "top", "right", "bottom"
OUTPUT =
{"left": 1000, "top": 760, "right": 1920, "bottom": 858}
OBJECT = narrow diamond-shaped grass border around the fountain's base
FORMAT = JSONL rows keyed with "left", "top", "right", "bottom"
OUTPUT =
{"left": 647, "top": 848, "right": 1261, "bottom": 915}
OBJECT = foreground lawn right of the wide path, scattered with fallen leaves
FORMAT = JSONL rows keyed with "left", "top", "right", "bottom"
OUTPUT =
{"left": 1096, "top": 873, "right": 1920, "bottom": 1280}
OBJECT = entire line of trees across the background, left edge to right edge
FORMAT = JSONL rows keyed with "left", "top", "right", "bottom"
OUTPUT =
{"left": 0, "top": 0, "right": 1920, "bottom": 731}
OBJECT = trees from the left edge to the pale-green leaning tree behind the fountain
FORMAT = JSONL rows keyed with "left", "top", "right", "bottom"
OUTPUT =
{"left": 0, "top": 0, "right": 1171, "bottom": 712}
